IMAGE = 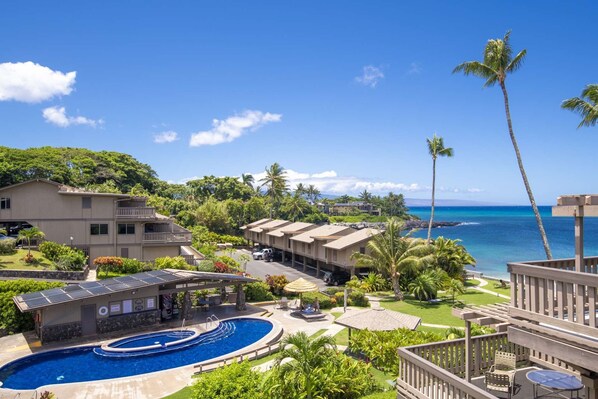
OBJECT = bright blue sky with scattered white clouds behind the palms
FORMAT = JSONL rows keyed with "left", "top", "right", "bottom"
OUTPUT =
{"left": 0, "top": 0, "right": 598, "bottom": 204}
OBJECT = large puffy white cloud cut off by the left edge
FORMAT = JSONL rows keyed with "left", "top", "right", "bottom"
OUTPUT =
{"left": 0, "top": 61, "right": 77, "bottom": 103}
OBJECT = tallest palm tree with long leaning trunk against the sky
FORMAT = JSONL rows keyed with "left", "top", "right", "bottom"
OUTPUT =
{"left": 453, "top": 31, "right": 552, "bottom": 259}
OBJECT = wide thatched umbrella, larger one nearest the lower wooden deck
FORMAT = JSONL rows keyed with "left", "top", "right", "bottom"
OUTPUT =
{"left": 334, "top": 307, "right": 421, "bottom": 337}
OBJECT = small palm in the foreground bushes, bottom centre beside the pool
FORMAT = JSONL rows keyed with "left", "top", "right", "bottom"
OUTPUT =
{"left": 274, "top": 331, "right": 336, "bottom": 399}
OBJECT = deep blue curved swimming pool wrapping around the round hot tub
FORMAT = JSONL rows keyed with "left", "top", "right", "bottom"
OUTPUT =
{"left": 0, "top": 318, "right": 274, "bottom": 389}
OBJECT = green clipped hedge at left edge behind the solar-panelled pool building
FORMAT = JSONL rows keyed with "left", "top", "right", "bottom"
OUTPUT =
{"left": 0, "top": 280, "right": 64, "bottom": 334}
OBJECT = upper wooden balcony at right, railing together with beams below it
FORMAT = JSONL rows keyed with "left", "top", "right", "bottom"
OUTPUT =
{"left": 508, "top": 258, "right": 598, "bottom": 372}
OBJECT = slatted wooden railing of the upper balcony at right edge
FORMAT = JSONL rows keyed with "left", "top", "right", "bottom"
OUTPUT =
{"left": 508, "top": 258, "right": 598, "bottom": 339}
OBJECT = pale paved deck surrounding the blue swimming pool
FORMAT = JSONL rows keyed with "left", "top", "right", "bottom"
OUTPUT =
{"left": 0, "top": 304, "right": 333, "bottom": 399}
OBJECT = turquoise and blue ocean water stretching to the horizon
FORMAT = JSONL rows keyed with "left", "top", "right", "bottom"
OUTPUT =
{"left": 410, "top": 206, "right": 598, "bottom": 278}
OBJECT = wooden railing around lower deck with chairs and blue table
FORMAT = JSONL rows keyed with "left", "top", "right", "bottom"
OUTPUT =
{"left": 397, "top": 333, "right": 528, "bottom": 399}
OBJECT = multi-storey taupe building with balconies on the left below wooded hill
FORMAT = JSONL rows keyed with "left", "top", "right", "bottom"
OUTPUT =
{"left": 0, "top": 179, "right": 201, "bottom": 263}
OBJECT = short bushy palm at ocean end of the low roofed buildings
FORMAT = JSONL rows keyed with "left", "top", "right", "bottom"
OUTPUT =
{"left": 351, "top": 218, "right": 434, "bottom": 300}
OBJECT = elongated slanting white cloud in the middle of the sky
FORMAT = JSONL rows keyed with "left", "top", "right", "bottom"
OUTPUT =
{"left": 189, "top": 110, "right": 282, "bottom": 147}
